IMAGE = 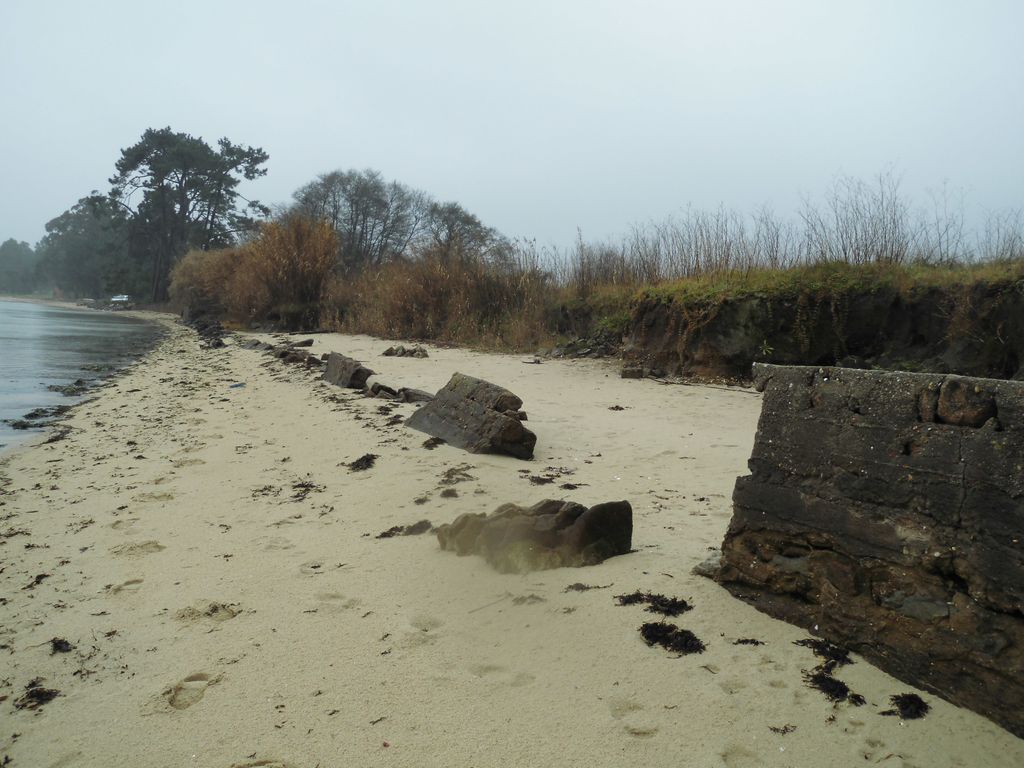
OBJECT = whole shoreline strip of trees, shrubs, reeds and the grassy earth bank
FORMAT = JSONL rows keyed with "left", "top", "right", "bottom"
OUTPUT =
{"left": 0, "top": 128, "right": 1024, "bottom": 379}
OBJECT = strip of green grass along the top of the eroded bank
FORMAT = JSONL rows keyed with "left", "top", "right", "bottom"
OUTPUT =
{"left": 633, "top": 259, "right": 1024, "bottom": 304}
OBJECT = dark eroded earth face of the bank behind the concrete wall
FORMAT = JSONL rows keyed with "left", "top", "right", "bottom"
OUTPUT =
{"left": 624, "top": 281, "right": 1024, "bottom": 380}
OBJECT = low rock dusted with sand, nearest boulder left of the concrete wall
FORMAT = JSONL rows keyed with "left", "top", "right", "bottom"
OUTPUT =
{"left": 437, "top": 499, "right": 633, "bottom": 573}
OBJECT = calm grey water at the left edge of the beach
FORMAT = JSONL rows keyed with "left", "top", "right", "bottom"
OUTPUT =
{"left": 0, "top": 299, "right": 161, "bottom": 449}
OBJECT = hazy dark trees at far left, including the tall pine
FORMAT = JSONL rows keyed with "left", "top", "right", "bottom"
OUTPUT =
{"left": 0, "top": 128, "right": 269, "bottom": 302}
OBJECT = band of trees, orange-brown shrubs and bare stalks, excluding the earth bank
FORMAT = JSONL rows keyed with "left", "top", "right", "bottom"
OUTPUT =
{"left": 0, "top": 128, "right": 1024, "bottom": 354}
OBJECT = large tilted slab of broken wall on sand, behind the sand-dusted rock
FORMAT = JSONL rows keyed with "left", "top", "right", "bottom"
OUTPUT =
{"left": 406, "top": 374, "right": 537, "bottom": 459}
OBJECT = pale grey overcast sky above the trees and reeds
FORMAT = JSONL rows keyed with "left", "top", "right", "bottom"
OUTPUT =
{"left": 0, "top": 0, "right": 1024, "bottom": 245}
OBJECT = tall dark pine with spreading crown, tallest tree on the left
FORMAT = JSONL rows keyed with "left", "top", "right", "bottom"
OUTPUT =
{"left": 110, "top": 128, "right": 268, "bottom": 301}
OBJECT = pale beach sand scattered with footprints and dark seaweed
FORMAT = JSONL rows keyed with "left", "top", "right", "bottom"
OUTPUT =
{"left": 0, "top": 326, "right": 1024, "bottom": 768}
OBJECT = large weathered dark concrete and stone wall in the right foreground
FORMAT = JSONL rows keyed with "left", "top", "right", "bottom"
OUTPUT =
{"left": 719, "top": 366, "right": 1024, "bottom": 736}
